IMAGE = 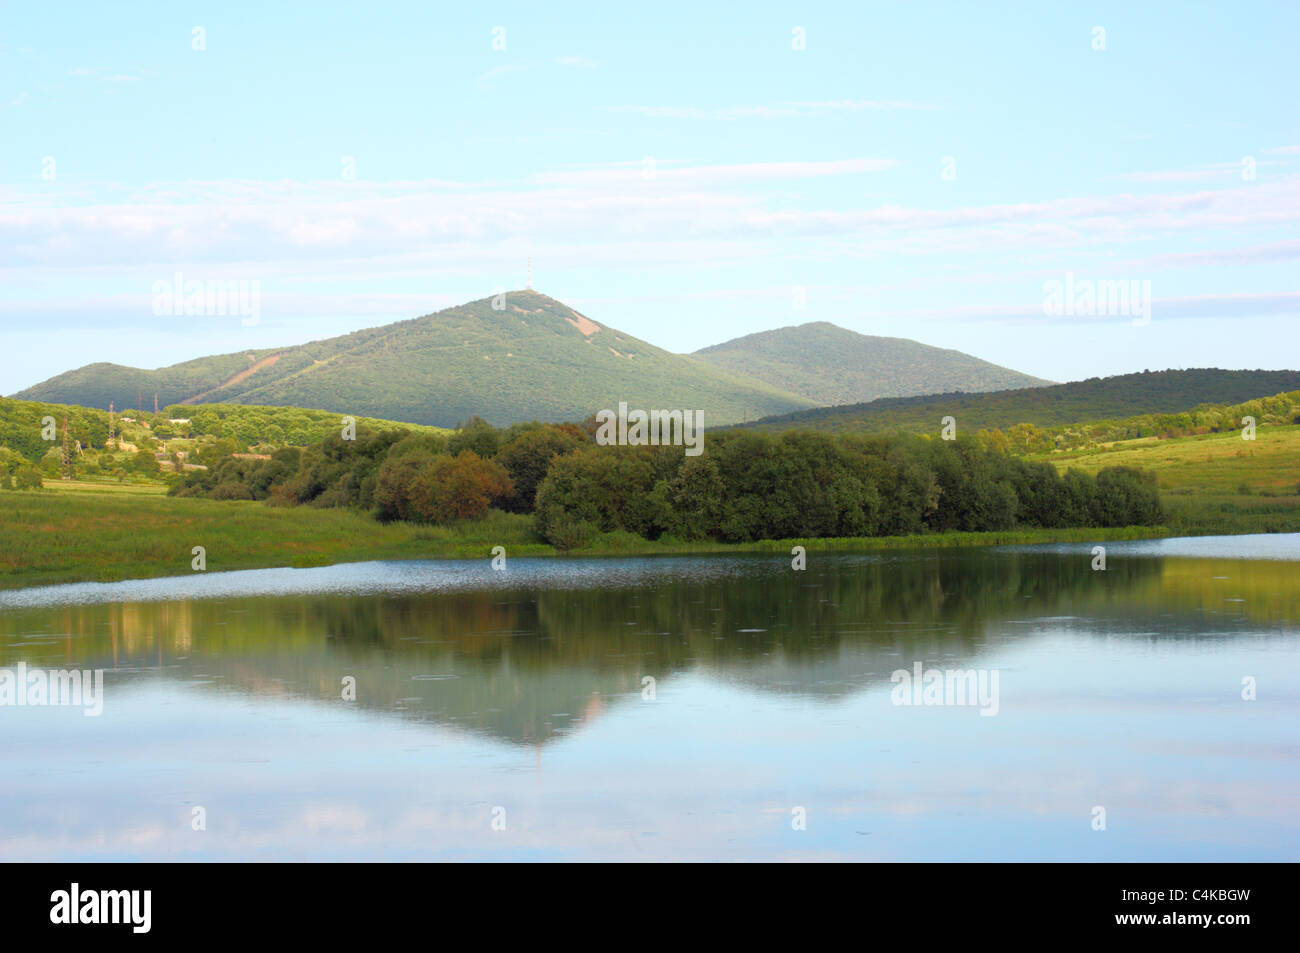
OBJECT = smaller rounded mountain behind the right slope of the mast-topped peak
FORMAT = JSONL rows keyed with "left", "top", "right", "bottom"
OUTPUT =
{"left": 696, "top": 321, "right": 1050, "bottom": 404}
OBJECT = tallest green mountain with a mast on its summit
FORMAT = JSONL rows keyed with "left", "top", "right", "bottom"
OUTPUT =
{"left": 16, "top": 290, "right": 815, "bottom": 426}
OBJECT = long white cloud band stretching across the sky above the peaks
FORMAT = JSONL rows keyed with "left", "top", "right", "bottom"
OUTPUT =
{"left": 0, "top": 170, "right": 1300, "bottom": 268}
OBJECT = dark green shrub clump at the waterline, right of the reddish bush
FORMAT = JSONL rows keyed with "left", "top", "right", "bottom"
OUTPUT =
{"left": 536, "top": 432, "right": 1164, "bottom": 546}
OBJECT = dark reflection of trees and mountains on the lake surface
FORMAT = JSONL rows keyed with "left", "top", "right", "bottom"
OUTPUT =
{"left": 0, "top": 551, "right": 1297, "bottom": 744}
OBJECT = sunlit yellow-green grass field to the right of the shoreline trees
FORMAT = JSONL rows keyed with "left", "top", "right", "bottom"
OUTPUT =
{"left": 1041, "top": 426, "right": 1300, "bottom": 536}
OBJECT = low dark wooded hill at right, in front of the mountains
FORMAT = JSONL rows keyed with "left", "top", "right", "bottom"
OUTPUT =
{"left": 750, "top": 368, "right": 1300, "bottom": 433}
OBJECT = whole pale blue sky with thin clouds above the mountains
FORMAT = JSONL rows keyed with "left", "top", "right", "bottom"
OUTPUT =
{"left": 0, "top": 0, "right": 1300, "bottom": 394}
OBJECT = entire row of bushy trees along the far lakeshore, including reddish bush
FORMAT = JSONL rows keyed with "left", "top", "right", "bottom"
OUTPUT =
{"left": 172, "top": 420, "right": 1164, "bottom": 549}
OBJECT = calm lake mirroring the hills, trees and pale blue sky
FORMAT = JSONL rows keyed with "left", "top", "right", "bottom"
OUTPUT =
{"left": 0, "top": 536, "right": 1300, "bottom": 861}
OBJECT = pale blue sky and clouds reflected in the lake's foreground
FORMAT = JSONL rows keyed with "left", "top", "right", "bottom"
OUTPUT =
{"left": 0, "top": 657, "right": 1296, "bottom": 859}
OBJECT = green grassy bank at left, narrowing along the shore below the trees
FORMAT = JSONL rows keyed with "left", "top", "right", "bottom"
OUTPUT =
{"left": 0, "top": 486, "right": 1169, "bottom": 589}
